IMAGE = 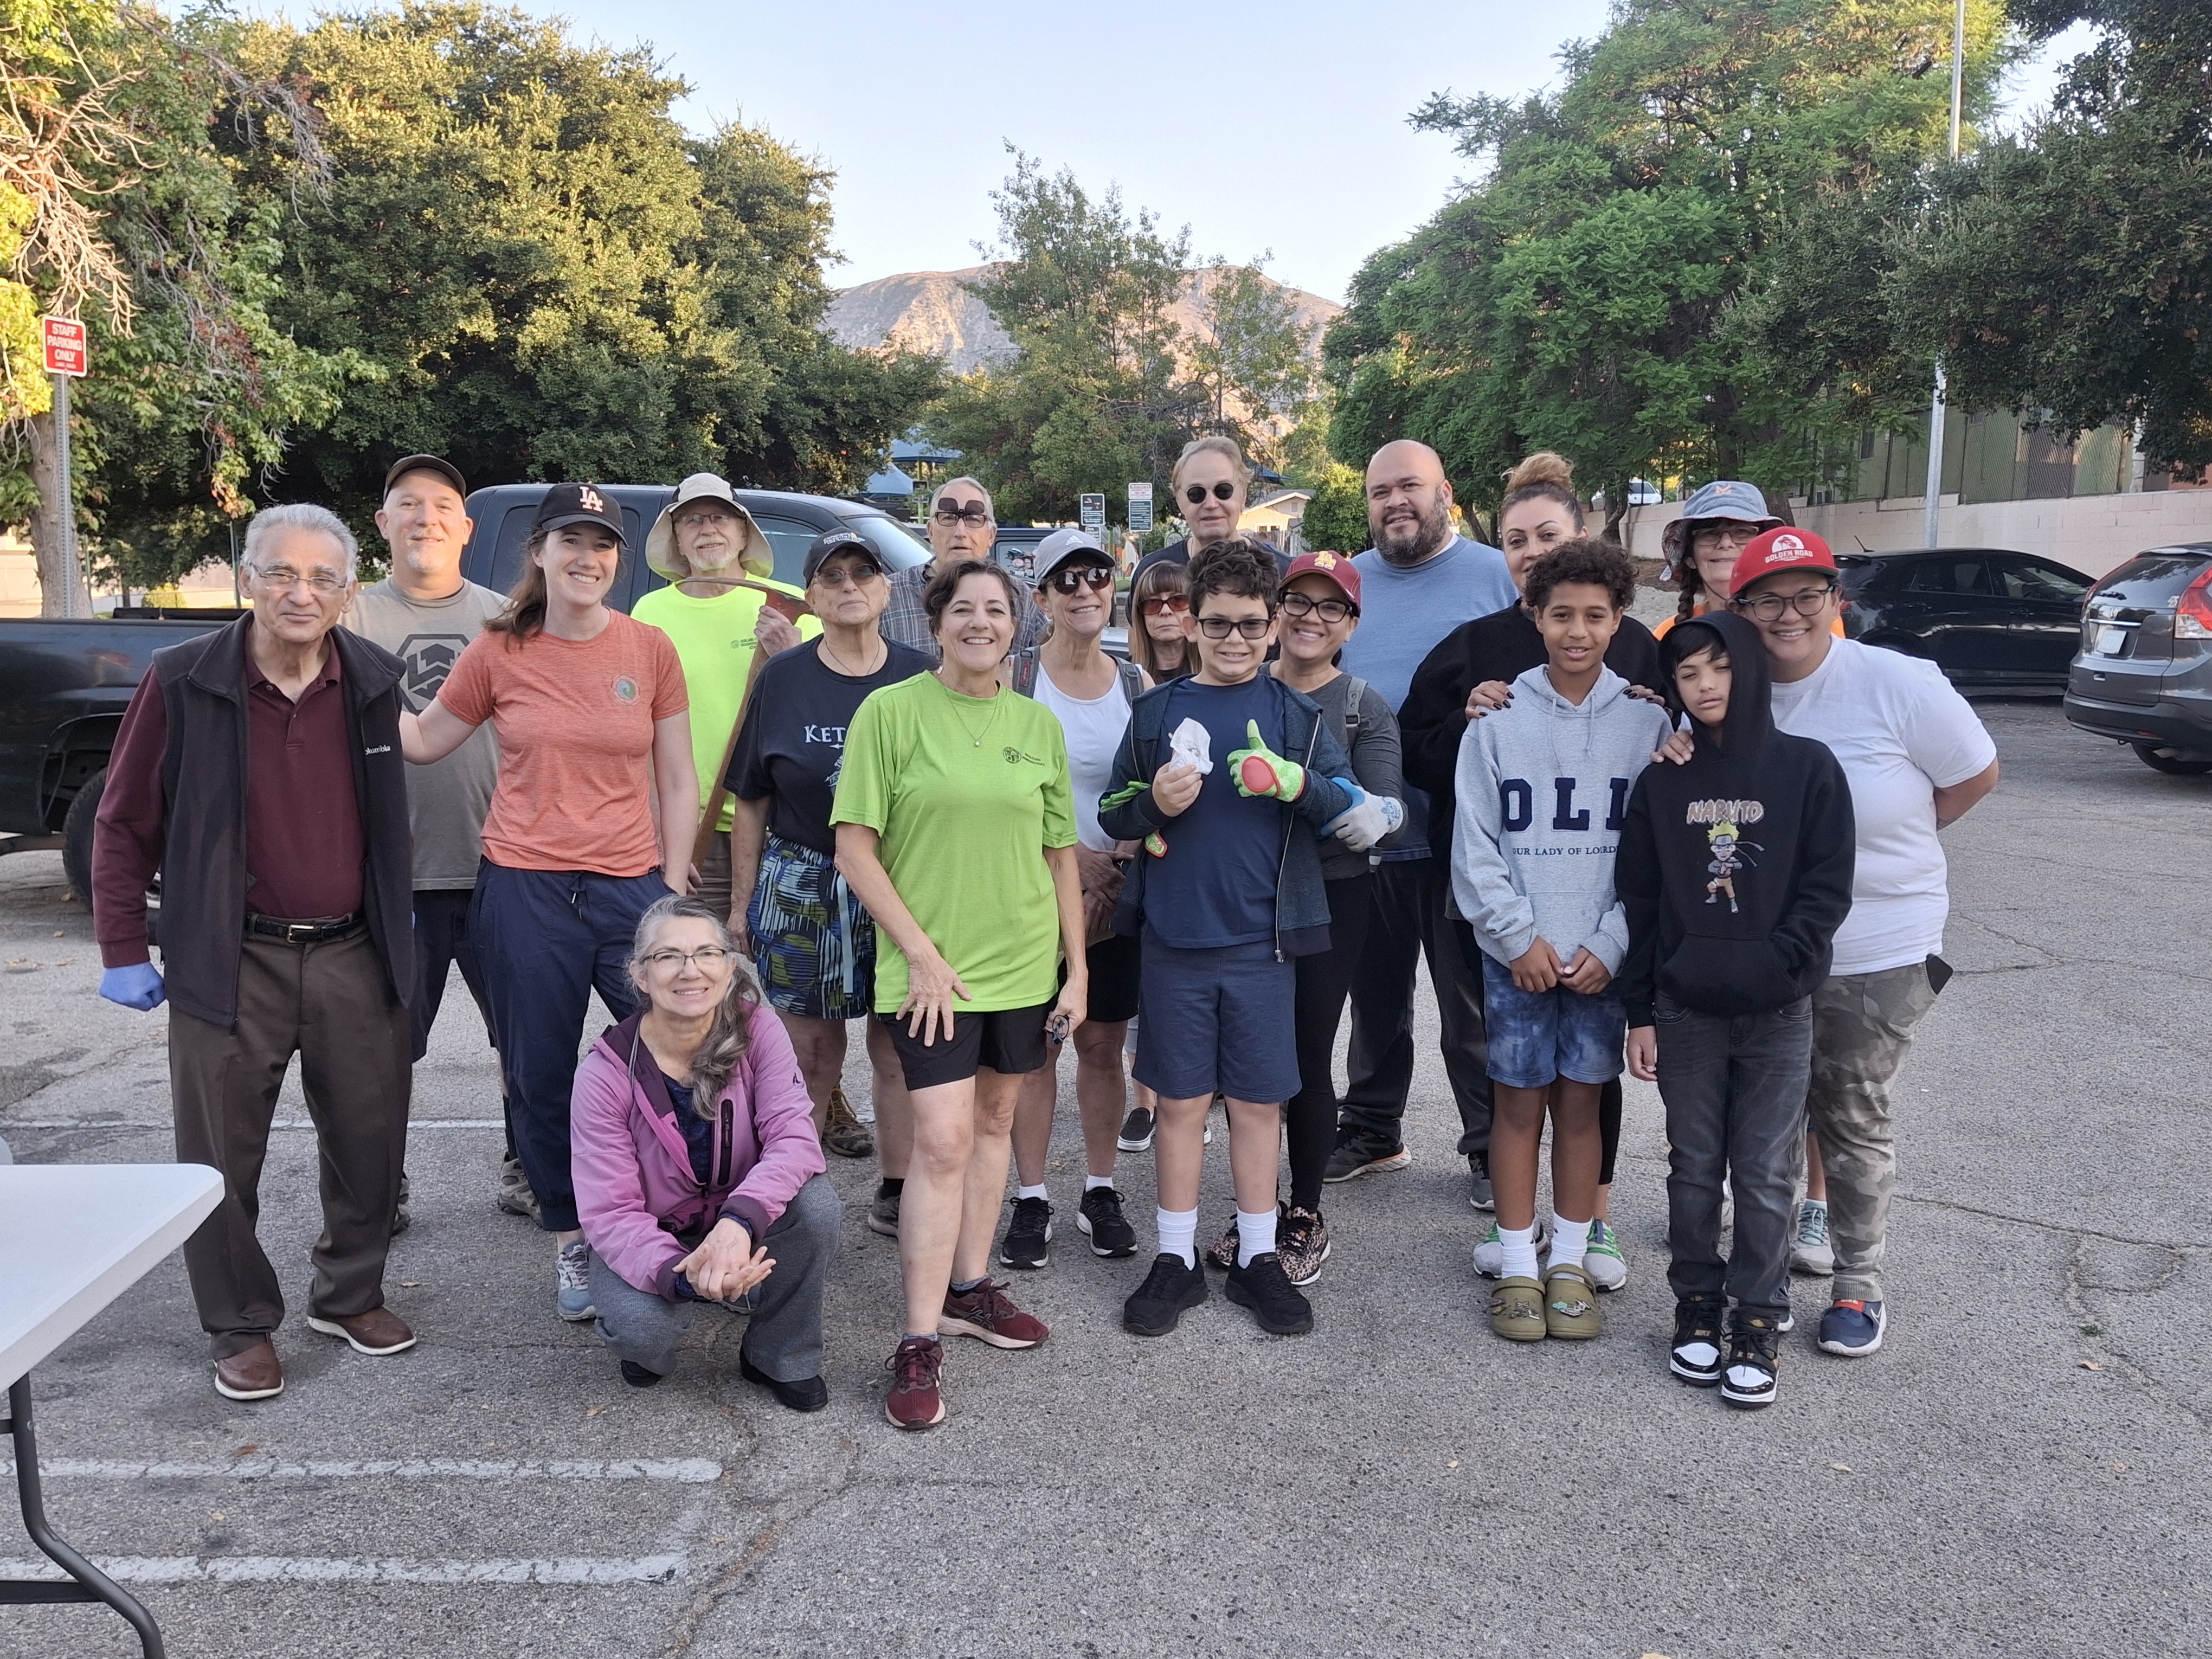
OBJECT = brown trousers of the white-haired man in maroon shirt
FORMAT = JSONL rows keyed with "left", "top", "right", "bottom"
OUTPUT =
{"left": 168, "top": 929, "right": 414, "bottom": 1360}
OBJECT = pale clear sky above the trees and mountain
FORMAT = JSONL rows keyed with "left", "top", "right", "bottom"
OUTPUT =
{"left": 237, "top": 0, "right": 2084, "bottom": 301}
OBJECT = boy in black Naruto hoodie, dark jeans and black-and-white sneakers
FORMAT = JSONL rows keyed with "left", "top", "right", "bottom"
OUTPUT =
{"left": 1615, "top": 610, "right": 1856, "bottom": 1407}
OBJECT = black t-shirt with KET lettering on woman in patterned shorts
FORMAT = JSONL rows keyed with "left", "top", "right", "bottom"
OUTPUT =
{"left": 728, "top": 639, "right": 936, "bottom": 854}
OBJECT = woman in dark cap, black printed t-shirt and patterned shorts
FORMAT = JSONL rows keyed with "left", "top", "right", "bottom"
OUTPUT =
{"left": 728, "top": 531, "right": 931, "bottom": 1239}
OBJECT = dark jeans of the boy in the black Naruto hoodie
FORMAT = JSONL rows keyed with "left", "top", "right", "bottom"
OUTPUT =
{"left": 1657, "top": 995, "right": 1812, "bottom": 1319}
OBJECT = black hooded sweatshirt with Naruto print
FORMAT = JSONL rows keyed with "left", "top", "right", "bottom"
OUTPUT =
{"left": 1615, "top": 610, "right": 1856, "bottom": 1026}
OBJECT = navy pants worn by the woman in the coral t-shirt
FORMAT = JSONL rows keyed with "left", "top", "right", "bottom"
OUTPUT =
{"left": 469, "top": 858, "right": 668, "bottom": 1232}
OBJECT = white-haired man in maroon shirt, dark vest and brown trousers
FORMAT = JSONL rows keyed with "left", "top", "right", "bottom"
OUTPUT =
{"left": 93, "top": 506, "right": 416, "bottom": 1400}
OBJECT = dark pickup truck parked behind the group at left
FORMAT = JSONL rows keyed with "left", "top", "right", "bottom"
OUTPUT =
{"left": 0, "top": 485, "right": 929, "bottom": 898}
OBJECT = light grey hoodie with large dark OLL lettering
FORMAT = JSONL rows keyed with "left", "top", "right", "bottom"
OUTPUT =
{"left": 1451, "top": 668, "right": 1672, "bottom": 973}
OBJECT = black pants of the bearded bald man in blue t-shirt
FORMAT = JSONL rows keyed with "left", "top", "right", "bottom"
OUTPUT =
{"left": 1338, "top": 858, "right": 1491, "bottom": 1153}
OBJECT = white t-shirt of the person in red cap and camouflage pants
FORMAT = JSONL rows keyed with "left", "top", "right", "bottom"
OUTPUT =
{"left": 1774, "top": 639, "right": 1997, "bottom": 973}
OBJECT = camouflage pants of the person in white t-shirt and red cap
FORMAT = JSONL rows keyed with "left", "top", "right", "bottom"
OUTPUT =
{"left": 1798, "top": 962, "right": 1935, "bottom": 1303}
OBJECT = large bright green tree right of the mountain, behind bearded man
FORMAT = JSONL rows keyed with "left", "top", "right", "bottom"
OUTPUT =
{"left": 1325, "top": 0, "right": 2013, "bottom": 524}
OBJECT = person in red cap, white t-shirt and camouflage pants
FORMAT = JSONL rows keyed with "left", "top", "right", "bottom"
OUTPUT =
{"left": 1707, "top": 526, "right": 1997, "bottom": 1358}
